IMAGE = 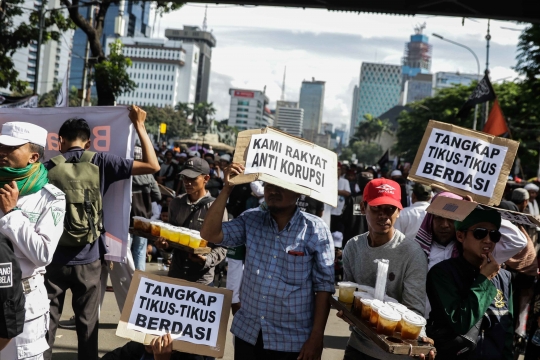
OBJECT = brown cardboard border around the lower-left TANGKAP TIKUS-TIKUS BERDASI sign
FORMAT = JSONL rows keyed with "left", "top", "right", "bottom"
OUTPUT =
{"left": 116, "top": 270, "right": 232, "bottom": 358}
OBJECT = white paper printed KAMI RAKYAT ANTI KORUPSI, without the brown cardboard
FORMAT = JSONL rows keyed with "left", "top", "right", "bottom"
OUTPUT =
{"left": 244, "top": 134, "right": 330, "bottom": 193}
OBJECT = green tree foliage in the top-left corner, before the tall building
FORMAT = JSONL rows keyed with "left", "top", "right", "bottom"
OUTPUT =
{"left": 0, "top": 0, "right": 75, "bottom": 93}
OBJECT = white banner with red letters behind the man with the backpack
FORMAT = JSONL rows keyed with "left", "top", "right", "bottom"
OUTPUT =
{"left": 0, "top": 106, "right": 135, "bottom": 262}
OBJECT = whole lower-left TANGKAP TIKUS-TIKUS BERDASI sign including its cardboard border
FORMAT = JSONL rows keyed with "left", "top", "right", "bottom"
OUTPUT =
{"left": 117, "top": 271, "right": 232, "bottom": 357}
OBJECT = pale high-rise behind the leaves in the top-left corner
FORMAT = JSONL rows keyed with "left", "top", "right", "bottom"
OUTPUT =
{"left": 0, "top": 0, "right": 73, "bottom": 94}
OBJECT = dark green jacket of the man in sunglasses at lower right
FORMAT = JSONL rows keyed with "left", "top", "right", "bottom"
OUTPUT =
{"left": 426, "top": 256, "right": 514, "bottom": 360}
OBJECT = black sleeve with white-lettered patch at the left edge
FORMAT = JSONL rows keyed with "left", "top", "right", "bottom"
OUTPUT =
{"left": 0, "top": 235, "right": 25, "bottom": 339}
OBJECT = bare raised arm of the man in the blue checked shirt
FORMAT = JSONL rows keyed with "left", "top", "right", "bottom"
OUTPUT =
{"left": 201, "top": 163, "right": 244, "bottom": 244}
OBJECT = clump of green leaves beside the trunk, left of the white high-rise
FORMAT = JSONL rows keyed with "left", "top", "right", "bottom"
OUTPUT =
{"left": 94, "top": 40, "right": 137, "bottom": 98}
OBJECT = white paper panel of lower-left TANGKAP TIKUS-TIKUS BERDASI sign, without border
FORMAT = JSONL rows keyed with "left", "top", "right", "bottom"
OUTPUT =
{"left": 127, "top": 277, "right": 224, "bottom": 347}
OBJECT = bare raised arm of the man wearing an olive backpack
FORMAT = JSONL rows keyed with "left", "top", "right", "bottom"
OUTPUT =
{"left": 129, "top": 105, "right": 159, "bottom": 175}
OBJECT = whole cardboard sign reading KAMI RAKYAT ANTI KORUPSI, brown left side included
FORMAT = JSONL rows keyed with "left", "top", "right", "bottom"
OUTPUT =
{"left": 231, "top": 128, "right": 337, "bottom": 206}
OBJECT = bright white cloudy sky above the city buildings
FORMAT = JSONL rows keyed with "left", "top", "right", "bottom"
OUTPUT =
{"left": 159, "top": 4, "right": 524, "bottom": 129}
